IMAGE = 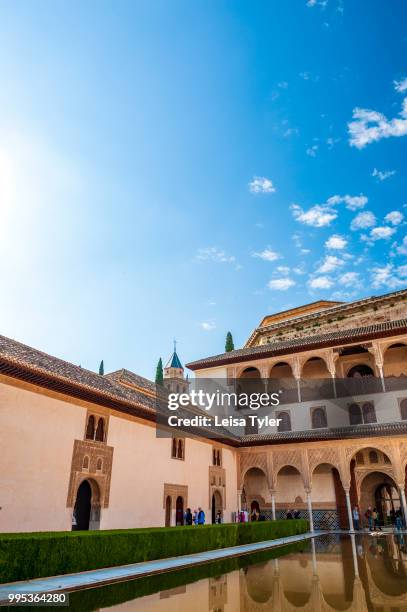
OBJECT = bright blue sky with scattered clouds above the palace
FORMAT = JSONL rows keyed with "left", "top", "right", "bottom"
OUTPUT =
{"left": 0, "top": 0, "right": 407, "bottom": 377}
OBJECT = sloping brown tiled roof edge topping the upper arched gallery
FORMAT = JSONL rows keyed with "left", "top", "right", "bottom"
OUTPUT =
{"left": 186, "top": 319, "right": 407, "bottom": 370}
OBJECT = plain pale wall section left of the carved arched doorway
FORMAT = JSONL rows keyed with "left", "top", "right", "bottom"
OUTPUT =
{"left": 0, "top": 383, "right": 86, "bottom": 532}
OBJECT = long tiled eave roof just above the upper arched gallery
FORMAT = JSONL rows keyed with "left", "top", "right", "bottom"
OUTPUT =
{"left": 186, "top": 319, "right": 407, "bottom": 370}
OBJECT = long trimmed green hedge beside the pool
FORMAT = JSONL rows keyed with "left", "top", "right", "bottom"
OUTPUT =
{"left": 0, "top": 519, "right": 308, "bottom": 582}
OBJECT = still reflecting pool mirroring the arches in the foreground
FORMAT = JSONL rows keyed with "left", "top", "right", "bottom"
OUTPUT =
{"left": 70, "top": 534, "right": 407, "bottom": 612}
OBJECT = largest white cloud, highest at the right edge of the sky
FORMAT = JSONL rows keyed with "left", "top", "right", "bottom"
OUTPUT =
{"left": 348, "top": 98, "right": 407, "bottom": 149}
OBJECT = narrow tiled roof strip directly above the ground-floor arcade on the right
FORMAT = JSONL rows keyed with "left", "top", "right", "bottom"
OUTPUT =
{"left": 240, "top": 421, "right": 407, "bottom": 446}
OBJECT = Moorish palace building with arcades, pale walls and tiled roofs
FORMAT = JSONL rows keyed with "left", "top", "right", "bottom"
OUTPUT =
{"left": 0, "top": 290, "right": 407, "bottom": 532}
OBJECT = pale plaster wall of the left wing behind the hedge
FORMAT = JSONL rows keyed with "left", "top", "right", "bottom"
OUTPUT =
{"left": 0, "top": 383, "right": 237, "bottom": 532}
